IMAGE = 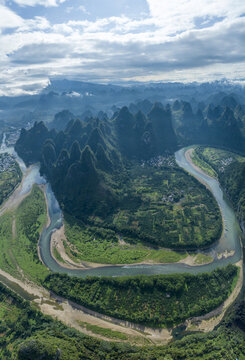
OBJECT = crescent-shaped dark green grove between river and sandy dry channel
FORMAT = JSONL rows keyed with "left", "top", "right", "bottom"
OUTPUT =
{"left": 44, "top": 265, "right": 238, "bottom": 327}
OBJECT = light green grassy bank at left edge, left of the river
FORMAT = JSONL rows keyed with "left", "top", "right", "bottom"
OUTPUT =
{"left": 0, "top": 186, "right": 49, "bottom": 282}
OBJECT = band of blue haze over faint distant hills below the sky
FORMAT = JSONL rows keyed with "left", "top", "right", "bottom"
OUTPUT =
{"left": 0, "top": 80, "right": 245, "bottom": 136}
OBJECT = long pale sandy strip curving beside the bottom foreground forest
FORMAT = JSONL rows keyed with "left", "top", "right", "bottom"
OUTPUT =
{"left": 0, "top": 269, "right": 172, "bottom": 346}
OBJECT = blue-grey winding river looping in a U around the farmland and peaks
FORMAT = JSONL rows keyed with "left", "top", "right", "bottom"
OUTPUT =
{"left": 0, "top": 138, "right": 242, "bottom": 277}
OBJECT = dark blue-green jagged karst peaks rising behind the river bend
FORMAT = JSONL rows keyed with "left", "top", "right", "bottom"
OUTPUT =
{"left": 15, "top": 92, "right": 245, "bottom": 216}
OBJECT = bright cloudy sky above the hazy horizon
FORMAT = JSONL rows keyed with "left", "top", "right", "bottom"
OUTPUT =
{"left": 0, "top": 0, "right": 245, "bottom": 96}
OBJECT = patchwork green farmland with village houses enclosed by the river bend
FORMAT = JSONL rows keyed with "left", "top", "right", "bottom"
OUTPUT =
{"left": 105, "top": 164, "right": 222, "bottom": 249}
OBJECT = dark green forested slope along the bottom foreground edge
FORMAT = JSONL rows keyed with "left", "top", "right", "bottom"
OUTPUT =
{"left": 0, "top": 283, "right": 245, "bottom": 360}
